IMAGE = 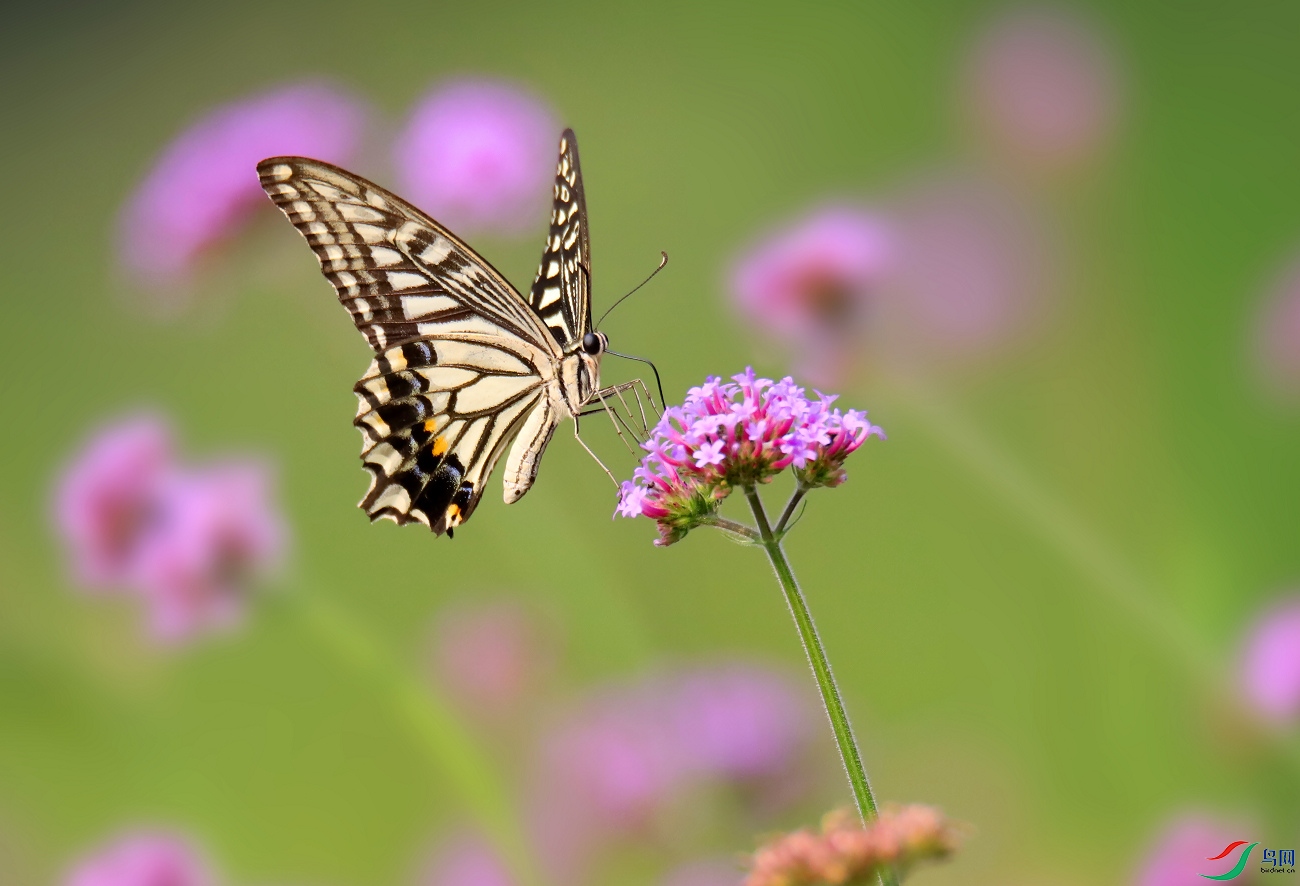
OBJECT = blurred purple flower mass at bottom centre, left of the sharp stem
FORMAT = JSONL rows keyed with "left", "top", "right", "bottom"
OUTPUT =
{"left": 532, "top": 663, "right": 810, "bottom": 882}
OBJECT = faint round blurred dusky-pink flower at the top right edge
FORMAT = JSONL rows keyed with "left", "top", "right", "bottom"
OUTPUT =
{"left": 965, "top": 6, "right": 1119, "bottom": 170}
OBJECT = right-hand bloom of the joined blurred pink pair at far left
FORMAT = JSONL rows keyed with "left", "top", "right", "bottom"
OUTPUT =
{"left": 135, "top": 462, "right": 285, "bottom": 640}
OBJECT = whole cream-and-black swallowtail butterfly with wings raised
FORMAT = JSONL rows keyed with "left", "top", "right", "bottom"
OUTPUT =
{"left": 257, "top": 130, "right": 653, "bottom": 537}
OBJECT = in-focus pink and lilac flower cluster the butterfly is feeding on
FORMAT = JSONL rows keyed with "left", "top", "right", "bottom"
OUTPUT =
{"left": 616, "top": 368, "right": 884, "bottom": 546}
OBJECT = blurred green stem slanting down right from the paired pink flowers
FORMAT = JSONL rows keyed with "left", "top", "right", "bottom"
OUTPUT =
{"left": 295, "top": 594, "right": 542, "bottom": 886}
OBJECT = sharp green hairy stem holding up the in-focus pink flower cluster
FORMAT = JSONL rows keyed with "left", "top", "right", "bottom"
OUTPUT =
{"left": 745, "top": 486, "right": 898, "bottom": 886}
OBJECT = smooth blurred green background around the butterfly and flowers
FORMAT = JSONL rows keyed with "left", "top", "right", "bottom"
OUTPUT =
{"left": 0, "top": 0, "right": 1300, "bottom": 886}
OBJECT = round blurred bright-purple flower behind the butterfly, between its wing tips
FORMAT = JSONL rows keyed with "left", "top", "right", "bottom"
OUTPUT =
{"left": 395, "top": 81, "right": 560, "bottom": 233}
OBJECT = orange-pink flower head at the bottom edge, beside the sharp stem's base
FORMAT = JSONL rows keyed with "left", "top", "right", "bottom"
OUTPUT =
{"left": 745, "top": 805, "right": 959, "bottom": 886}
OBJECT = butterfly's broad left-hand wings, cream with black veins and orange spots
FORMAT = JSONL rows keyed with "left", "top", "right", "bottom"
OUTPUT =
{"left": 257, "top": 157, "right": 564, "bottom": 534}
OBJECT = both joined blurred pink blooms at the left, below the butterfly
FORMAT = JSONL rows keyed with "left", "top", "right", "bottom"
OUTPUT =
{"left": 55, "top": 417, "right": 285, "bottom": 642}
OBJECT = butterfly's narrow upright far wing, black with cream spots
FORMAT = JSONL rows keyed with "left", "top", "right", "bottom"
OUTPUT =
{"left": 528, "top": 130, "right": 592, "bottom": 348}
